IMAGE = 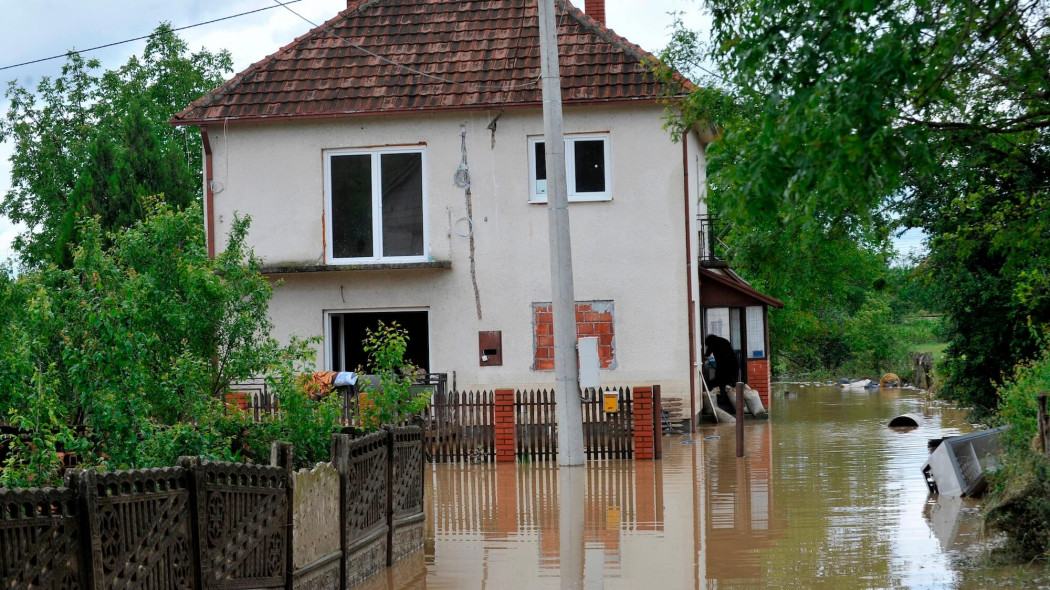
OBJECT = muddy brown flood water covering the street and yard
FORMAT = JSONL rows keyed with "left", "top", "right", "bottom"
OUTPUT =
{"left": 356, "top": 385, "right": 1050, "bottom": 590}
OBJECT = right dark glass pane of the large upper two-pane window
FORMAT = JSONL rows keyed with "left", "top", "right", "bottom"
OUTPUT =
{"left": 380, "top": 153, "right": 423, "bottom": 256}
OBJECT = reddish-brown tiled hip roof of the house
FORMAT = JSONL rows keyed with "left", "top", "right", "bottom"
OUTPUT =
{"left": 172, "top": 0, "right": 680, "bottom": 125}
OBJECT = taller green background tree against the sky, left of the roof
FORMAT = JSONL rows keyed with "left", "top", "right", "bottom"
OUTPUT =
{"left": 0, "top": 24, "right": 232, "bottom": 268}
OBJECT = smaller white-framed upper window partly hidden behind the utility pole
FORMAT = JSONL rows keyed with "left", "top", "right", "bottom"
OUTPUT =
{"left": 528, "top": 133, "right": 612, "bottom": 203}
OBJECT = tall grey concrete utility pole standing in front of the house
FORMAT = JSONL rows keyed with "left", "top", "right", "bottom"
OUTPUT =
{"left": 537, "top": 0, "right": 584, "bottom": 466}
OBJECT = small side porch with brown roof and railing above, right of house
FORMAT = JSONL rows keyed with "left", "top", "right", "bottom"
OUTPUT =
{"left": 697, "top": 215, "right": 784, "bottom": 407}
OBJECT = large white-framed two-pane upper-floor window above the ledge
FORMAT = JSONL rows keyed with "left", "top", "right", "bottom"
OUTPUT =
{"left": 324, "top": 146, "right": 427, "bottom": 265}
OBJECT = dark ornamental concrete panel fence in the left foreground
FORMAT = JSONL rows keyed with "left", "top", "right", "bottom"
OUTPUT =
{"left": 0, "top": 426, "right": 424, "bottom": 590}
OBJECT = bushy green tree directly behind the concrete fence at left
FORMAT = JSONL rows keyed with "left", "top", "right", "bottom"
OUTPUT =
{"left": 0, "top": 202, "right": 337, "bottom": 485}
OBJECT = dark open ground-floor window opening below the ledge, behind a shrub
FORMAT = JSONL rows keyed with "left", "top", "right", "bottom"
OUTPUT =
{"left": 326, "top": 310, "right": 431, "bottom": 373}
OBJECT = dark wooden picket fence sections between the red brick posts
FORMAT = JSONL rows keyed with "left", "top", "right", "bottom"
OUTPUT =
{"left": 425, "top": 387, "right": 634, "bottom": 463}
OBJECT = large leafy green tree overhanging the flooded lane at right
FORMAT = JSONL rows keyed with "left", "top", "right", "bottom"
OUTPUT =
{"left": 665, "top": 0, "right": 1050, "bottom": 403}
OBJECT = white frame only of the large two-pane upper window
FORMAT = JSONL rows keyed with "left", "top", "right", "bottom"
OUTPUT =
{"left": 323, "top": 145, "right": 431, "bottom": 265}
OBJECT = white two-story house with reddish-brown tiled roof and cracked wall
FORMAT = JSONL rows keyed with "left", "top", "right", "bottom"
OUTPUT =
{"left": 173, "top": 0, "right": 776, "bottom": 417}
